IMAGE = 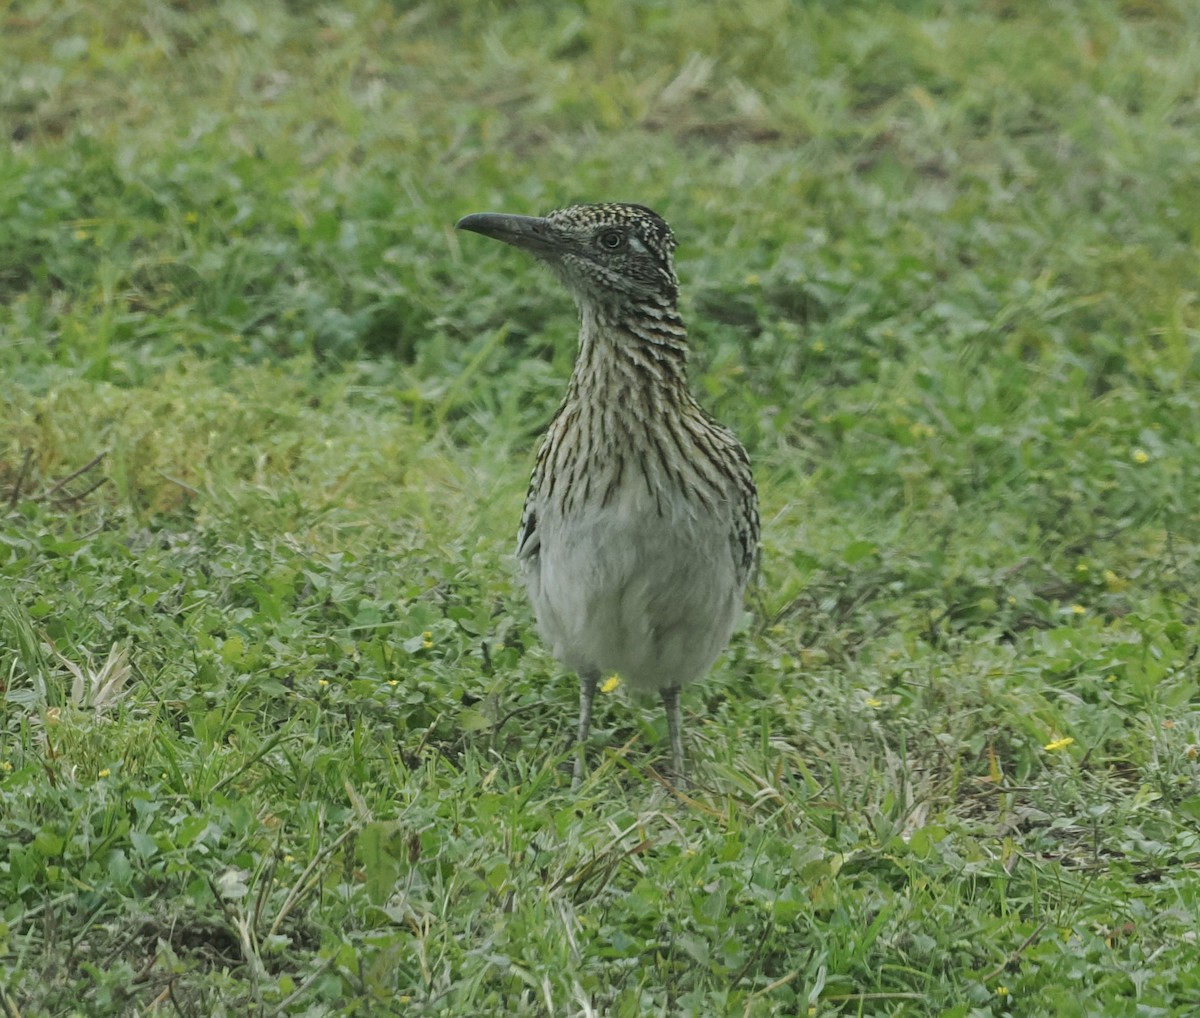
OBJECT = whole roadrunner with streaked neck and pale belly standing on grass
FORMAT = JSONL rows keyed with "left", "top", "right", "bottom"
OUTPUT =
{"left": 456, "top": 202, "right": 760, "bottom": 786}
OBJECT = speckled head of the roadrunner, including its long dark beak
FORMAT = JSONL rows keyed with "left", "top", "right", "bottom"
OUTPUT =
{"left": 457, "top": 203, "right": 679, "bottom": 312}
